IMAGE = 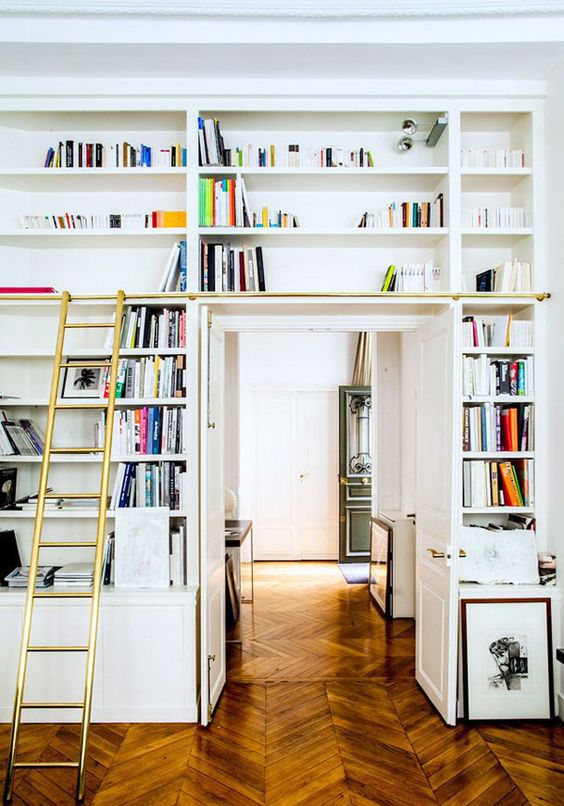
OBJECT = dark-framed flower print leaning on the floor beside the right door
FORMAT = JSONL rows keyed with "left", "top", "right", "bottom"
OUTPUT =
{"left": 461, "top": 598, "right": 554, "bottom": 719}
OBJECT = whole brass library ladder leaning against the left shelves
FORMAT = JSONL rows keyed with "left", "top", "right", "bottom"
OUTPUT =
{"left": 4, "top": 291, "right": 125, "bottom": 801}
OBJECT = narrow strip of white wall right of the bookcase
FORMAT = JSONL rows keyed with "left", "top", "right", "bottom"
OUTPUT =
{"left": 542, "top": 61, "right": 564, "bottom": 718}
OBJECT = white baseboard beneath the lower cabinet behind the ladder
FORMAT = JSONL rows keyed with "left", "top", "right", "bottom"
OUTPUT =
{"left": 0, "top": 704, "right": 198, "bottom": 723}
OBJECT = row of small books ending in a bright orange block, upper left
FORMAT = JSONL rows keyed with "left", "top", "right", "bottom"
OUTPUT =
{"left": 20, "top": 210, "right": 186, "bottom": 231}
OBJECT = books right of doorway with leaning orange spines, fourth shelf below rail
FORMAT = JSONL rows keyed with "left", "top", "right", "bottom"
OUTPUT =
{"left": 462, "top": 459, "right": 534, "bottom": 507}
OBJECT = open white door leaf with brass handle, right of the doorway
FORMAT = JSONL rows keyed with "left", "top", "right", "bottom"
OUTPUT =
{"left": 415, "top": 306, "right": 458, "bottom": 725}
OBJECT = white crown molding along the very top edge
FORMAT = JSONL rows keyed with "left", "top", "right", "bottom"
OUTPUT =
{"left": 0, "top": 0, "right": 564, "bottom": 19}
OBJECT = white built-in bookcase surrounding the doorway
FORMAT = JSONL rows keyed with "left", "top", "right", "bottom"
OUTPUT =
{"left": 0, "top": 98, "right": 550, "bottom": 721}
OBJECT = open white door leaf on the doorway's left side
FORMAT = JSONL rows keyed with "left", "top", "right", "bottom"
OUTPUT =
{"left": 200, "top": 308, "right": 225, "bottom": 725}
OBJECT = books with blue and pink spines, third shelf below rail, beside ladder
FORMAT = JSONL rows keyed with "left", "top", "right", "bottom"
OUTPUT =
{"left": 94, "top": 406, "right": 185, "bottom": 456}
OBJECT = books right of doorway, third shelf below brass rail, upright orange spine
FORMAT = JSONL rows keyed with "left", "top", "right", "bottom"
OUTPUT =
{"left": 462, "top": 403, "right": 534, "bottom": 451}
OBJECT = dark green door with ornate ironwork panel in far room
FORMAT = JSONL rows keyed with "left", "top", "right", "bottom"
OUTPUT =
{"left": 339, "top": 386, "right": 372, "bottom": 562}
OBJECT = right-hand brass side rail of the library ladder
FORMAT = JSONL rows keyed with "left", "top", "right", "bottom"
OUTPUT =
{"left": 77, "top": 291, "right": 125, "bottom": 801}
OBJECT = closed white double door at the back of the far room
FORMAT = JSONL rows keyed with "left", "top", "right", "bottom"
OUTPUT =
{"left": 251, "top": 388, "right": 339, "bottom": 560}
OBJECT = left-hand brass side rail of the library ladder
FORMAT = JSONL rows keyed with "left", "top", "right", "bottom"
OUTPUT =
{"left": 4, "top": 291, "right": 70, "bottom": 800}
